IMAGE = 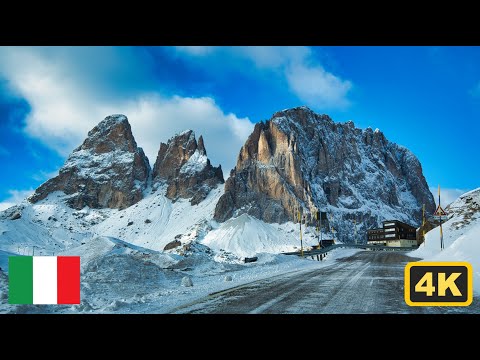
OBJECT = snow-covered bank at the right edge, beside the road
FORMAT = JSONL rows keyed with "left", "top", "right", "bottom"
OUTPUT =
{"left": 411, "top": 188, "right": 480, "bottom": 292}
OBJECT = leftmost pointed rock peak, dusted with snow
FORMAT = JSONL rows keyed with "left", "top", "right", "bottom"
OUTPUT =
{"left": 29, "top": 115, "right": 150, "bottom": 209}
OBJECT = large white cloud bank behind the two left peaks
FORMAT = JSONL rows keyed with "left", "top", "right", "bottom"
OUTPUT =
{"left": 0, "top": 48, "right": 253, "bottom": 174}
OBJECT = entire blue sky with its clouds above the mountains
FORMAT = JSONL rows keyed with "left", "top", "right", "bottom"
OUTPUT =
{"left": 0, "top": 47, "right": 480, "bottom": 209}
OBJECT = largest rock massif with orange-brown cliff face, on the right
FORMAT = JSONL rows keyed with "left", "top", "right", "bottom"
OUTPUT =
{"left": 214, "top": 107, "right": 435, "bottom": 241}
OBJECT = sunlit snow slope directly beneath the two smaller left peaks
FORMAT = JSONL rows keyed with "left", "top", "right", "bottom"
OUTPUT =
{"left": 0, "top": 186, "right": 222, "bottom": 255}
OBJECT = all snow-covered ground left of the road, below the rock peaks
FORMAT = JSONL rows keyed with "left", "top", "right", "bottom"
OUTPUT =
{"left": 0, "top": 190, "right": 344, "bottom": 313}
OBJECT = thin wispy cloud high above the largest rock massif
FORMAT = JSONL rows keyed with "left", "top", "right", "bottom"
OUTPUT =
{"left": 173, "top": 46, "right": 352, "bottom": 109}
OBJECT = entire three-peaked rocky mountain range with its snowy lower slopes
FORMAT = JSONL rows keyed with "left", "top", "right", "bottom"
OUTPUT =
{"left": 0, "top": 107, "right": 434, "bottom": 256}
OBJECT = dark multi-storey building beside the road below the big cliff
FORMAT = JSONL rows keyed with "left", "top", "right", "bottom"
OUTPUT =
{"left": 367, "top": 220, "right": 417, "bottom": 247}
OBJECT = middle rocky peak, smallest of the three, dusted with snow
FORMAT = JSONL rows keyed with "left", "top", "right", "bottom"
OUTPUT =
{"left": 152, "top": 130, "right": 224, "bottom": 205}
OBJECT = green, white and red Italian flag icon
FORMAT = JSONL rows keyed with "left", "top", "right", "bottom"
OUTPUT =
{"left": 8, "top": 256, "right": 80, "bottom": 304}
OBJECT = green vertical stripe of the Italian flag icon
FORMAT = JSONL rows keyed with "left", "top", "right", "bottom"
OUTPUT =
{"left": 8, "top": 256, "right": 33, "bottom": 304}
